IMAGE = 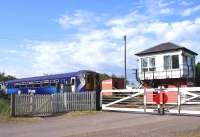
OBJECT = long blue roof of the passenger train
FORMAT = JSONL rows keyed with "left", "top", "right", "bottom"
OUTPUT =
{"left": 6, "top": 70, "right": 96, "bottom": 84}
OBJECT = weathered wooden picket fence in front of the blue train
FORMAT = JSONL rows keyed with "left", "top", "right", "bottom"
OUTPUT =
{"left": 11, "top": 92, "right": 96, "bottom": 116}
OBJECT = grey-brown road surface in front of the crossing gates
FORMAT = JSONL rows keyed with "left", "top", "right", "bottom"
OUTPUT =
{"left": 0, "top": 112, "right": 200, "bottom": 137}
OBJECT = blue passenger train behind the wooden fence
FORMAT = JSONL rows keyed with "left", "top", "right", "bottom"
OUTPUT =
{"left": 1, "top": 70, "right": 100, "bottom": 94}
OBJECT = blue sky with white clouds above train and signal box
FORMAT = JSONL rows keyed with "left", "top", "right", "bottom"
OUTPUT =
{"left": 0, "top": 0, "right": 200, "bottom": 83}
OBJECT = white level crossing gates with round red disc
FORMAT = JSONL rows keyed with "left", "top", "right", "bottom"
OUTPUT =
{"left": 101, "top": 87, "right": 200, "bottom": 115}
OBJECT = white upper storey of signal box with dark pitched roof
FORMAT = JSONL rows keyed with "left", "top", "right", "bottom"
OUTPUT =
{"left": 135, "top": 42, "right": 198, "bottom": 88}
